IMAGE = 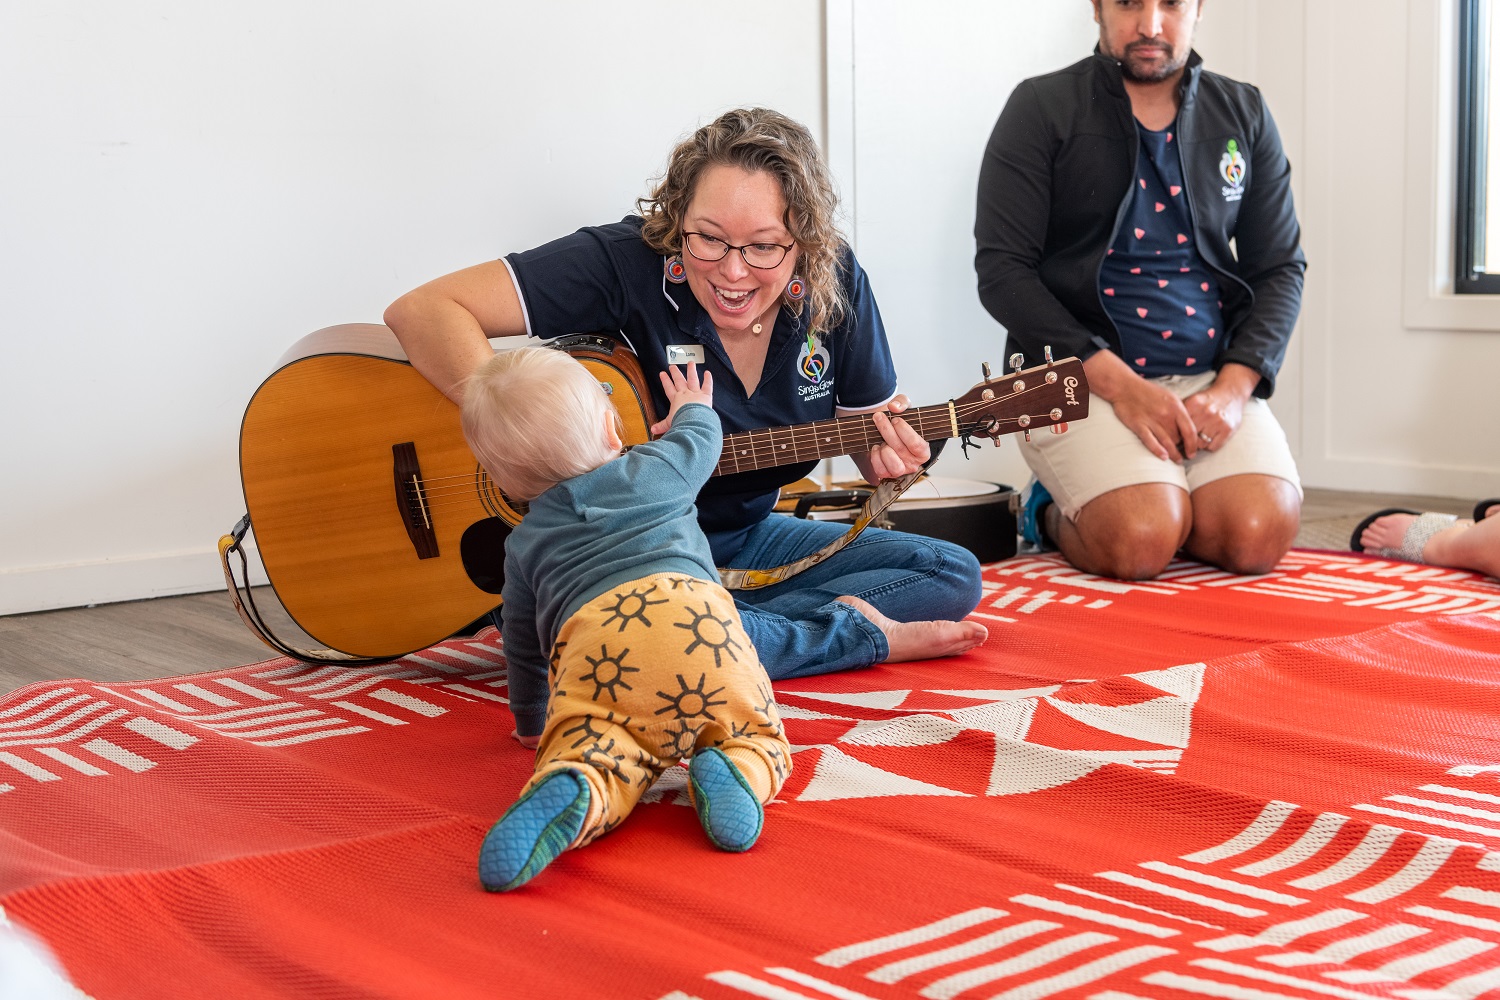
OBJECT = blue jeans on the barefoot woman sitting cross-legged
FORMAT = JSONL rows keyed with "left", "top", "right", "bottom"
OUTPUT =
{"left": 717, "top": 514, "right": 980, "bottom": 681}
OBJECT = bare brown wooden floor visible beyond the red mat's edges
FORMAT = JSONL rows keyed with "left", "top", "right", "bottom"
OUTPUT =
{"left": 0, "top": 490, "right": 1475, "bottom": 693}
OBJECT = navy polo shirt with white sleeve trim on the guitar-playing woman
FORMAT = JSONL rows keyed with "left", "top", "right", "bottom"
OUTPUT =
{"left": 506, "top": 216, "right": 896, "bottom": 565}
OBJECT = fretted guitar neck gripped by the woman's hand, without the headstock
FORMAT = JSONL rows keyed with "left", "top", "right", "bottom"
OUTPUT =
{"left": 714, "top": 402, "right": 960, "bottom": 475}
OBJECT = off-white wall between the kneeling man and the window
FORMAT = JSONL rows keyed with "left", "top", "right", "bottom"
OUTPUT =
{"left": 1203, "top": 0, "right": 1500, "bottom": 498}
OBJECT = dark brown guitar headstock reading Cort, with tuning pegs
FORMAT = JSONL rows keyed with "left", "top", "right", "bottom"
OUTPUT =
{"left": 953, "top": 349, "right": 1089, "bottom": 441}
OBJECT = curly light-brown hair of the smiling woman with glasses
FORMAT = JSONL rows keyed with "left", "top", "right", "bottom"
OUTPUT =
{"left": 636, "top": 108, "right": 848, "bottom": 331}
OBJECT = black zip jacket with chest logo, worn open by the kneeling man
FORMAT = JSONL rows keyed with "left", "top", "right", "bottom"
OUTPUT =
{"left": 974, "top": 52, "right": 1307, "bottom": 397}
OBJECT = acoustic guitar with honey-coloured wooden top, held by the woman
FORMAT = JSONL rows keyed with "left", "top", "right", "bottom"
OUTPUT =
{"left": 231, "top": 324, "right": 1089, "bottom": 658}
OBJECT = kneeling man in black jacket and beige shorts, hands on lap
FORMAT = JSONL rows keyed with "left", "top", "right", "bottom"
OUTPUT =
{"left": 975, "top": 0, "right": 1307, "bottom": 580}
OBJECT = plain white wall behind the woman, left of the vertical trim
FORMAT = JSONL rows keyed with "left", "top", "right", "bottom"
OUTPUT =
{"left": 0, "top": 0, "right": 825, "bottom": 613}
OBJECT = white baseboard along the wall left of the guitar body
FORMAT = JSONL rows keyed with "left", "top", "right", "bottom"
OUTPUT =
{"left": 0, "top": 546, "right": 267, "bottom": 615}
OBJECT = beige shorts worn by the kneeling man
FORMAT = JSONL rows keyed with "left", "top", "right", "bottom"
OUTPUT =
{"left": 1020, "top": 372, "right": 1302, "bottom": 520}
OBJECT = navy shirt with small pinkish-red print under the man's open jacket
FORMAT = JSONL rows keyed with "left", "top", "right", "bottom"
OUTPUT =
{"left": 1100, "top": 121, "right": 1224, "bottom": 378}
